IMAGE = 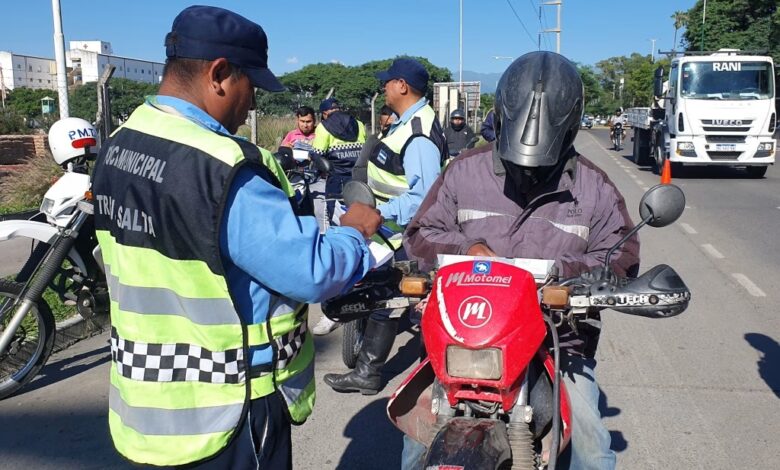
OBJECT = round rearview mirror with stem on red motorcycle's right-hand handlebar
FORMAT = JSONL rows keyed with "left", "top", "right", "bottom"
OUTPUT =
{"left": 603, "top": 184, "right": 685, "bottom": 279}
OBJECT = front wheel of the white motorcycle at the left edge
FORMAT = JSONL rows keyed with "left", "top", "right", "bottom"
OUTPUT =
{"left": 0, "top": 279, "right": 54, "bottom": 399}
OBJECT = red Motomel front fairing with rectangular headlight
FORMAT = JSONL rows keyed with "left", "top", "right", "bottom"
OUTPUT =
{"left": 422, "top": 260, "right": 546, "bottom": 409}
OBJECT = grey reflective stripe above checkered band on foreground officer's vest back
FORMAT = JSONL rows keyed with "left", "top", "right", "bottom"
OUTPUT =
{"left": 106, "top": 265, "right": 241, "bottom": 325}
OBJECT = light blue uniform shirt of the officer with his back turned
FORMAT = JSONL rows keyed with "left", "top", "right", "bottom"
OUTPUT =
{"left": 147, "top": 96, "right": 371, "bottom": 365}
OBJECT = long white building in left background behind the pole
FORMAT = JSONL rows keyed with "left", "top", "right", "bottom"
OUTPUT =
{"left": 0, "top": 41, "right": 164, "bottom": 90}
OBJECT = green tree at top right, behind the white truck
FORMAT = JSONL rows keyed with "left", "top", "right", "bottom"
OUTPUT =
{"left": 683, "top": 0, "right": 780, "bottom": 62}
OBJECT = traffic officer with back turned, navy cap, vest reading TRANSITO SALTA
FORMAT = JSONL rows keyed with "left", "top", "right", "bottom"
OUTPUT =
{"left": 93, "top": 6, "right": 380, "bottom": 469}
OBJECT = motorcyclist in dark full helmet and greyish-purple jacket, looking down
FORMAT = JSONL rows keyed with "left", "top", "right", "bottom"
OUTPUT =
{"left": 403, "top": 51, "right": 639, "bottom": 470}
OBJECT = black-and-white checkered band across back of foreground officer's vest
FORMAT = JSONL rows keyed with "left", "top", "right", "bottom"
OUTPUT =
{"left": 111, "top": 328, "right": 245, "bottom": 384}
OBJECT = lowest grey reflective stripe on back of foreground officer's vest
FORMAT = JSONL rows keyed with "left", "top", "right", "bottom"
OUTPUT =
{"left": 108, "top": 385, "right": 239, "bottom": 436}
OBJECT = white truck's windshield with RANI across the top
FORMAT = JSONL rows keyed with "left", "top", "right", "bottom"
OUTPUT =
{"left": 680, "top": 61, "right": 775, "bottom": 100}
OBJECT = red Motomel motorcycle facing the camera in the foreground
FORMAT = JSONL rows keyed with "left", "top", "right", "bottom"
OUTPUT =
{"left": 387, "top": 185, "right": 691, "bottom": 470}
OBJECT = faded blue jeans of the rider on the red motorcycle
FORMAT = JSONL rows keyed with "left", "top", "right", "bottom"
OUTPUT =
{"left": 401, "top": 356, "right": 615, "bottom": 470}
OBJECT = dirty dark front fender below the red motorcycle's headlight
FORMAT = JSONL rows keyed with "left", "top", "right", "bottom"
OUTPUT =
{"left": 425, "top": 418, "right": 512, "bottom": 470}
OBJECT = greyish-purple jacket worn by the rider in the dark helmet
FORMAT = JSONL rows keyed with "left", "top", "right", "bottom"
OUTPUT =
{"left": 404, "top": 146, "right": 639, "bottom": 356}
